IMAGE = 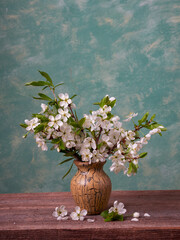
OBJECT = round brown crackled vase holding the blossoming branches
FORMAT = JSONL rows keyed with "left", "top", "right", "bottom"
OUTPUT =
{"left": 71, "top": 160, "right": 111, "bottom": 215}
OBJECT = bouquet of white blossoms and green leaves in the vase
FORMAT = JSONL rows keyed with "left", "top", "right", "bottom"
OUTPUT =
{"left": 21, "top": 72, "right": 166, "bottom": 176}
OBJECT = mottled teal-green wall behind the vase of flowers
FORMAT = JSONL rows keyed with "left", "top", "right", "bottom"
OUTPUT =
{"left": 0, "top": 0, "right": 180, "bottom": 193}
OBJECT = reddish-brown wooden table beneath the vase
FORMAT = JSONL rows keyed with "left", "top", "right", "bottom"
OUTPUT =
{"left": 0, "top": 190, "right": 180, "bottom": 240}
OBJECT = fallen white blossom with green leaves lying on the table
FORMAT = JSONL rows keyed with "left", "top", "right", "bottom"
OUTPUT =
{"left": 101, "top": 200, "right": 126, "bottom": 222}
